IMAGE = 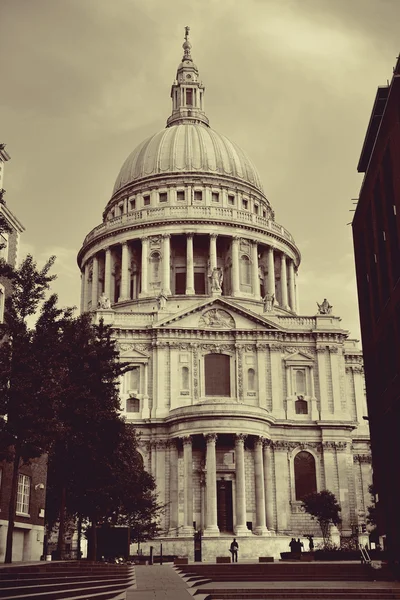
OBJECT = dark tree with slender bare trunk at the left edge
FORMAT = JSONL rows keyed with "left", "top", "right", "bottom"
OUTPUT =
{"left": 0, "top": 255, "right": 70, "bottom": 563}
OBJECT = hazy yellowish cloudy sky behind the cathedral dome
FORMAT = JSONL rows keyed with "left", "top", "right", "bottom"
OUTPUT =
{"left": 0, "top": 0, "right": 400, "bottom": 339}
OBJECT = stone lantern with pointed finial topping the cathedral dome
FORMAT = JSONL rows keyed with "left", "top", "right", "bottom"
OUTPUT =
{"left": 167, "top": 27, "right": 208, "bottom": 127}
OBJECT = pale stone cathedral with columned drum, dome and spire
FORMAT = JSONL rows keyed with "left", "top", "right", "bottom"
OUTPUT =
{"left": 78, "top": 28, "right": 372, "bottom": 560}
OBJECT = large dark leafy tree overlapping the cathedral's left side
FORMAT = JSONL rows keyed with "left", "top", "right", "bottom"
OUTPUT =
{"left": 46, "top": 314, "right": 155, "bottom": 558}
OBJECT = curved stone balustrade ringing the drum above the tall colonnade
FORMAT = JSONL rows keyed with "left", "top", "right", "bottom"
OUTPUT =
{"left": 83, "top": 205, "right": 295, "bottom": 245}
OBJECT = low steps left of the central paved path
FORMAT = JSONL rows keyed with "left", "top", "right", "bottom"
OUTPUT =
{"left": 0, "top": 560, "right": 135, "bottom": 600}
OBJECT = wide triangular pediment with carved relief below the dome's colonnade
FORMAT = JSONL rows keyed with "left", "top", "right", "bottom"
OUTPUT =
{"left": 154, "top": 298, "right": 282, "bottom": 331}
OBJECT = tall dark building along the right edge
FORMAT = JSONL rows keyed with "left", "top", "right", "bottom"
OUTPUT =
{"left": 353, "top": 57, "right": 400, "bottom": 561}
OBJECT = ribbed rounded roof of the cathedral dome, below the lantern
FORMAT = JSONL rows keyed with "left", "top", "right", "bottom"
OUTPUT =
{"left": 113, "top": 121, "right": 263, "bottom": 194}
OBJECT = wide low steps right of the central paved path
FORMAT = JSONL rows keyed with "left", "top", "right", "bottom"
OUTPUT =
{"left": 176, "top": 563, "right": 400, "bottom": 600}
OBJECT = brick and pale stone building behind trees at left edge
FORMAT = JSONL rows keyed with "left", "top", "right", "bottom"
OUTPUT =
{"left": 0, "top": 144, "right": 47, "bottom": 562}
